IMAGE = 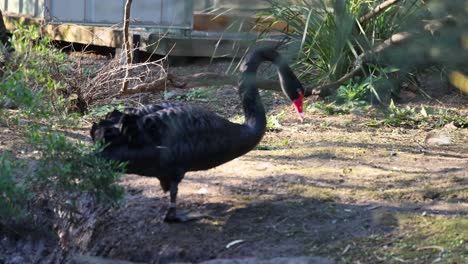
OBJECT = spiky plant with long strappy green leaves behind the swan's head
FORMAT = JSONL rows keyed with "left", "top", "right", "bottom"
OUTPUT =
{"left": 261, "top": 0, "right": 426, "bottom": 96}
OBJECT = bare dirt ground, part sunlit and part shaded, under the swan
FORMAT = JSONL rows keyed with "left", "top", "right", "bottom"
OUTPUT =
{"left": 0, "top": 56, "right": 468, "bottom": 263}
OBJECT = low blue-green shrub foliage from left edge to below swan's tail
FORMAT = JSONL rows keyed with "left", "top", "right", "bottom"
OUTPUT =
{"left": 0, "top": 128, "right": 124, "bottom": 225}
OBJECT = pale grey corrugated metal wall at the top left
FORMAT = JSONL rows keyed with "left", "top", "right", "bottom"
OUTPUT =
{"left": 0, "top": 0, "right": 193, "bottom": 28}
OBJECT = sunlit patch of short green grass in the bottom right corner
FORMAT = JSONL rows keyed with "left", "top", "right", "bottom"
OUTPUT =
{"left": 311, "top": 213, "right": 468, "bottom": 264}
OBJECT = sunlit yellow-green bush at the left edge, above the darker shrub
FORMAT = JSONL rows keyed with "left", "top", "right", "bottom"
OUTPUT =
{"left": 0, "top": 23, "right": 69, "bottom": 116}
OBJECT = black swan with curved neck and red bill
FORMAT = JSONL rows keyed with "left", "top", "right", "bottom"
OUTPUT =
{"left": 91, "top": 48, "right": 304, "bottom": 222}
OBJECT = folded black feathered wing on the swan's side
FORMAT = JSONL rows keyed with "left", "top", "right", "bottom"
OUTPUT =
{"left": 122, "top": 105, "right": 248, "bottom": 169}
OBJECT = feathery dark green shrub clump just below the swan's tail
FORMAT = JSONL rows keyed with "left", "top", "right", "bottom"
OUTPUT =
{"left": 27, "top": 129, "right": 124, "bottom": 209}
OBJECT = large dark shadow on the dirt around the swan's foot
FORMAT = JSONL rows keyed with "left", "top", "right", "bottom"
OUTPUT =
{"left": 77, "top": 175, "right": 428, "bottom": 263}
